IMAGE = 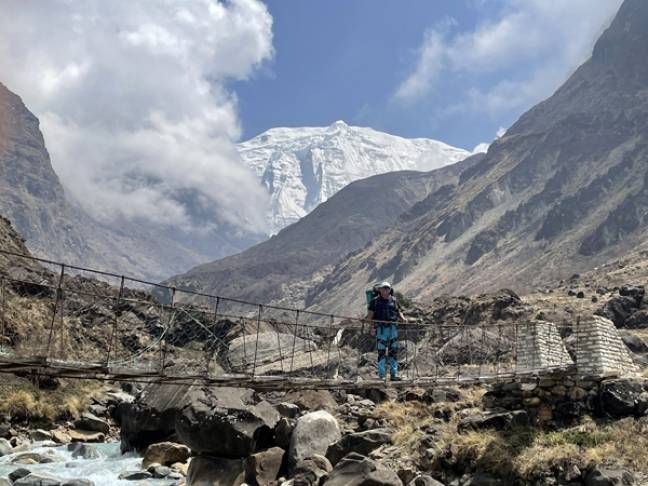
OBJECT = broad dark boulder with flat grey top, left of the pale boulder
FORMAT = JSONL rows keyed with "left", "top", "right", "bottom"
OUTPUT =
{"left": 175, "top": 388, "right": 280, "bottom": 458}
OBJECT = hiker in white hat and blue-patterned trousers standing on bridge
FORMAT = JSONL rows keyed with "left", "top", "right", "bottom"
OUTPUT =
{"left": 367, "top": 282, "right": 405, "bottom": 380}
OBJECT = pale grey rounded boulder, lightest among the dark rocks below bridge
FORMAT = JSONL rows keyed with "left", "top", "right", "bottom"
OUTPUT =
{"left": 288, "top": 410, "right": 342, "bottom": 467}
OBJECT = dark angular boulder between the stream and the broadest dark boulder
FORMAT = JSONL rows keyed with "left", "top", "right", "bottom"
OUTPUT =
{"left": 118, "top": 385, "right": 190, "bottom": 452}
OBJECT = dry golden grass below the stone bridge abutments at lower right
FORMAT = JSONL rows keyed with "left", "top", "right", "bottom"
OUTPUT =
{"left": 377, "top": 392, "right": 648, "bottom": 480}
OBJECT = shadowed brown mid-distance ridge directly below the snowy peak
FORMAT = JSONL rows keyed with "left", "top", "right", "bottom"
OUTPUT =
{"left": 169, "top": 155, "right": 482, "bottom": 304}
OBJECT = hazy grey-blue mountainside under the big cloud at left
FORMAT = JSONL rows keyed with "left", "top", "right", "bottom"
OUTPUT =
{"left": 0, "top": 84, "right": 258, "bottom": 280}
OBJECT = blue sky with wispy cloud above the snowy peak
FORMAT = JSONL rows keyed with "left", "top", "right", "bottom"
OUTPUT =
{"left": 232, "top": 0, "right": 620, "bottom": 149}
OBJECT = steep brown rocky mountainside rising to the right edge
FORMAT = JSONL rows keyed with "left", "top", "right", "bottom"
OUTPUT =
{"left": 309, "top": 0, "right": 648, "bottom": 316}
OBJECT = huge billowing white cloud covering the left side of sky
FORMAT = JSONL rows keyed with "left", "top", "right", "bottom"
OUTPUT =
{"left": 0, "top": 0, "right": 273, "bottom": 234}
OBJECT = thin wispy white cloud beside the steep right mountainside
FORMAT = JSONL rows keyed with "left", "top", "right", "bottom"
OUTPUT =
{"left": 394, "top": 0, "right": 622, "bottom": 113}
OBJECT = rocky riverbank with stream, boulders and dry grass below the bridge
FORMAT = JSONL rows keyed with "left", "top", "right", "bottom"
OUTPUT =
{"left": 0, "top": 377, "right": 648, "bottom": 486}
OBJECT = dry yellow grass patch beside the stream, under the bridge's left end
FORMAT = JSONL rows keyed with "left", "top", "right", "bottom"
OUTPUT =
{"left": 0, "top": 376, "right": 105, "bottom": 423}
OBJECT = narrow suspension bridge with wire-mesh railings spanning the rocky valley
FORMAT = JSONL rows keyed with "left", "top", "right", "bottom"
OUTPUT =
{"left": 0, "top": 250, "right": 632, "bottom": 390}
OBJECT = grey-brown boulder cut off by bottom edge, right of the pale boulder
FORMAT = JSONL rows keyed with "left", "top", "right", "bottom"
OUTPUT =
{"left": 323, "top": 453, "right": 403, "bottom": 486}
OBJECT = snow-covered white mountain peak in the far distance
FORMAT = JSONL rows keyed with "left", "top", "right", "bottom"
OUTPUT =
{"left": 238, "top": 121, "right": 470, "bottom": 232}
